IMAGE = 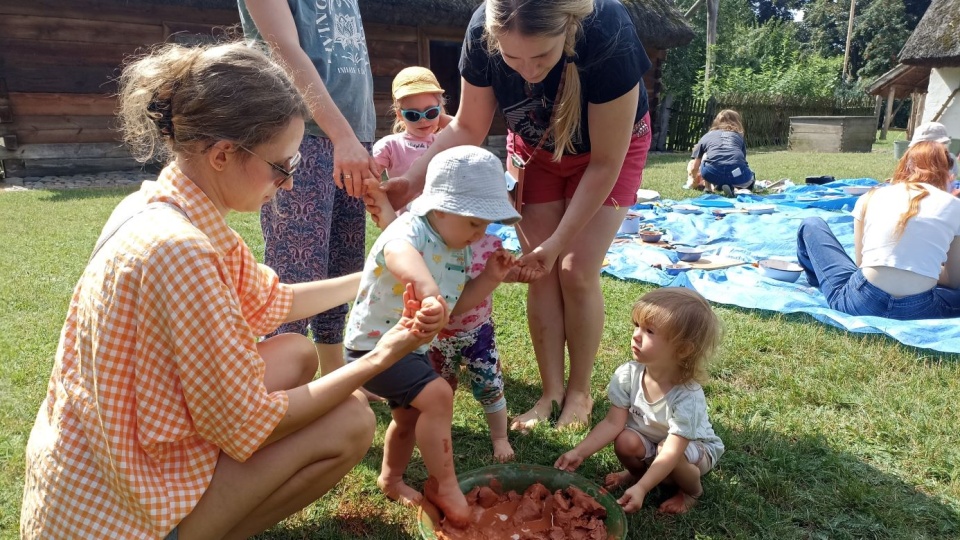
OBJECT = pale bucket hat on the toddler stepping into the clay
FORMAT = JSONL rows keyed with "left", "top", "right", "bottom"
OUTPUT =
{"left": 410, "top": 146, "right": 520, "bottom": 225}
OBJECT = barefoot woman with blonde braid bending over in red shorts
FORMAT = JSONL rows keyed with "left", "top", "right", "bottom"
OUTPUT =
{"left": 368, "top": 0, "right": 650, "bottom": 430}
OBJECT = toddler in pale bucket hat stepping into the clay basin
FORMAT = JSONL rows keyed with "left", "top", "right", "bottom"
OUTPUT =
{"left": 344, "top": 146, "right": 520, "bottom": 524}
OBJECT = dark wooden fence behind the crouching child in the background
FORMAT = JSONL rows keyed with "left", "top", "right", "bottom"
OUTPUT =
{"left": 655, "top": 95, "right": 874, "bottom": 152}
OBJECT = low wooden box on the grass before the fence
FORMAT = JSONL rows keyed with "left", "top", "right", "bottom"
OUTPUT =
{"left": 789, "top": 116, "right": 877, "bottom": 152}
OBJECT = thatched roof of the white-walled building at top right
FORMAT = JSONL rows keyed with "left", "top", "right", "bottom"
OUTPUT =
{"left": 900, "top": 0, "right": 960, "bottom": 67}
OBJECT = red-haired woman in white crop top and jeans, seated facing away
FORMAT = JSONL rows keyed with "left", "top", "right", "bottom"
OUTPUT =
{"left": 797, "top": 142, "right": 960, "bottom": 320}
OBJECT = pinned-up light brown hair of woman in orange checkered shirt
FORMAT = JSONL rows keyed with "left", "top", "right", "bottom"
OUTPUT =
{"left": 118, "top": 42, "right": 310, "bottom": 162}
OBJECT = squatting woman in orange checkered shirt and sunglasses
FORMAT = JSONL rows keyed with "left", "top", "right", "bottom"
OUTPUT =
{"left": 20, "top": 43, "right": 446, "bottom": 540}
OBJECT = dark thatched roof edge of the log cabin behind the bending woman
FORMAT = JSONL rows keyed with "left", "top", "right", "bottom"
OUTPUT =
{"left": 360, "top": 0, "right": 694, "bottom": 49}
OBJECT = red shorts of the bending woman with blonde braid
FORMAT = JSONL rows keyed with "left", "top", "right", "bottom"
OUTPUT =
{"left": 507, "top": 113, "right": 653, "bottom": 206}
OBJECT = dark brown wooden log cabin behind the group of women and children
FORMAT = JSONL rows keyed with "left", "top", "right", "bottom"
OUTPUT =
{"left": 0, "top": 0, "right": 693, "bottom": 179}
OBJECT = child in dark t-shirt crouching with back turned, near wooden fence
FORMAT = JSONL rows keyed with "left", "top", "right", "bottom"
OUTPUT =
{"left": 685, "top": 109, "right": 753, "bottom": 197}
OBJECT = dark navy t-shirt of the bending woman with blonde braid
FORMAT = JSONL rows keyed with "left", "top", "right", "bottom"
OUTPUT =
{"left": 460, "top": 0, "right": 650, "bottom": 154}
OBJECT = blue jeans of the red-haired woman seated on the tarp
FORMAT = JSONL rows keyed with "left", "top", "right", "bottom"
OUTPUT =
{"left": 797, "top": 217, "right": 960, "bottom": 320}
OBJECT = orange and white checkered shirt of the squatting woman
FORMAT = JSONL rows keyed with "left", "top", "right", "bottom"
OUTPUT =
{"left": 20, "top": 165, "right": 293, "bottom": 540}
